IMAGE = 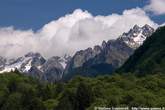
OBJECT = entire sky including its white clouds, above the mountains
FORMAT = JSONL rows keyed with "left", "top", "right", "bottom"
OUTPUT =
{"left": 0, "top": 0, "right": 165, "bottom": 58}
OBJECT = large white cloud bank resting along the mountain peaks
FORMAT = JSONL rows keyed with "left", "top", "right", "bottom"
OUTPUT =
{"left": 0, "top": 8, "right": 157, "bottom": 57}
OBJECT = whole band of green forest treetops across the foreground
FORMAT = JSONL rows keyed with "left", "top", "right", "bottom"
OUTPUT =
{"left": 0, "top": 73, "right": 165, "bottom": 110}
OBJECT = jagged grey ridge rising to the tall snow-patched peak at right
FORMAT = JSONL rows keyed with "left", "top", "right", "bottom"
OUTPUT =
{"left": 64, "top": 24, "right": 154, "bottom": 79}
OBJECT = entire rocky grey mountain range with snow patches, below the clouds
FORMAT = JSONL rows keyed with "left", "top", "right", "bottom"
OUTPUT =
{"left": 0, "top": 24, "right": 155, "bottom": 82}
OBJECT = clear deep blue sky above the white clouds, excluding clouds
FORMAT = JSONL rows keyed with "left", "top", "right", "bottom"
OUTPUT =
{"left": 0, "top": 0, "right": 165, "bottom": 30}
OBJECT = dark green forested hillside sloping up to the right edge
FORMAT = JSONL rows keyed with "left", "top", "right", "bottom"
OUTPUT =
{"left": 118, "top": 26, "right": 165, "bottom": 74}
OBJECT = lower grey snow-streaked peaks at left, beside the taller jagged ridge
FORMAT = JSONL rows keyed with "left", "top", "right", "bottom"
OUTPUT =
{"left": 0, "top": 52, "right": 71, "bottom": 82}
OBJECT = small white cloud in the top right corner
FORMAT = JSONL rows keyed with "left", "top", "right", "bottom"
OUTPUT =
{"left": 144, "top": 0, "right": 165, "bottom": 15}
